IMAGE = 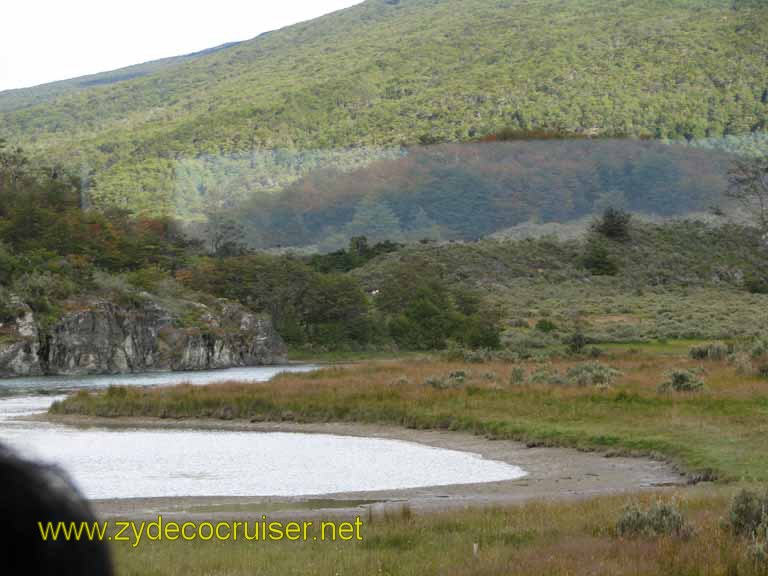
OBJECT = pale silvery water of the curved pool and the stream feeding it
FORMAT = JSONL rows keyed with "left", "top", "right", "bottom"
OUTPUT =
{"left": 0, "top": 366, "right": 525, "bottom": 498}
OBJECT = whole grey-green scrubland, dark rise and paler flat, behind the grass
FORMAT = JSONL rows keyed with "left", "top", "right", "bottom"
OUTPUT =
{"left": 354, "top": 220, "right": 768, "bottom": 342}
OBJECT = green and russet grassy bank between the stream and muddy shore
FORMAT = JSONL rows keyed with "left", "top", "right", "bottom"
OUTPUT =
{"left": 51, "top": 351, "right": 768, "bottom": 481}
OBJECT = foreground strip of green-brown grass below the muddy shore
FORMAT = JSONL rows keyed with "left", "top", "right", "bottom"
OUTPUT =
{"left": 114, "top": 489, "right": 764, "bottom": 576}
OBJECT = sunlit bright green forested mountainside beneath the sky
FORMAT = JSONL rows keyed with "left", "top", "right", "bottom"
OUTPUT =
{"left": 0, "top": 0, "right": 768, "bottom": 212}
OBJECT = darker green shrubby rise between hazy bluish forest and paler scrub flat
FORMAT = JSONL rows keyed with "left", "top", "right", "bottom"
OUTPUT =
{"left": 355, "top": 220, "right": 768, "bottom": 291}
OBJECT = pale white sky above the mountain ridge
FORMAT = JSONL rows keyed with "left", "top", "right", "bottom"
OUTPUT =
{"left": 0, "top": 0, "right": 361, "bottom": 90}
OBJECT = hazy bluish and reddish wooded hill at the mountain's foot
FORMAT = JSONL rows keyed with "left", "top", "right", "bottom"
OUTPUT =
{"left": 237, "top": 139, "right": 733, "bottom": 250}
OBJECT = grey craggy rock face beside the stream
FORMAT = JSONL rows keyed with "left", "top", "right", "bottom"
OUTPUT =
{"left": 0, "top": 299, "right": 286, "bottom": 377}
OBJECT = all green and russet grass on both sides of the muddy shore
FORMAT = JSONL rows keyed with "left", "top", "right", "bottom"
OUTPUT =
{"left": 52, "top": 341, "right": 768, "bottom": 576}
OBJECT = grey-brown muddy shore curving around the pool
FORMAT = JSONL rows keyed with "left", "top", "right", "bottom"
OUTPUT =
{"left": 40, "top": 414, "right": 686, "bottom": 520}
